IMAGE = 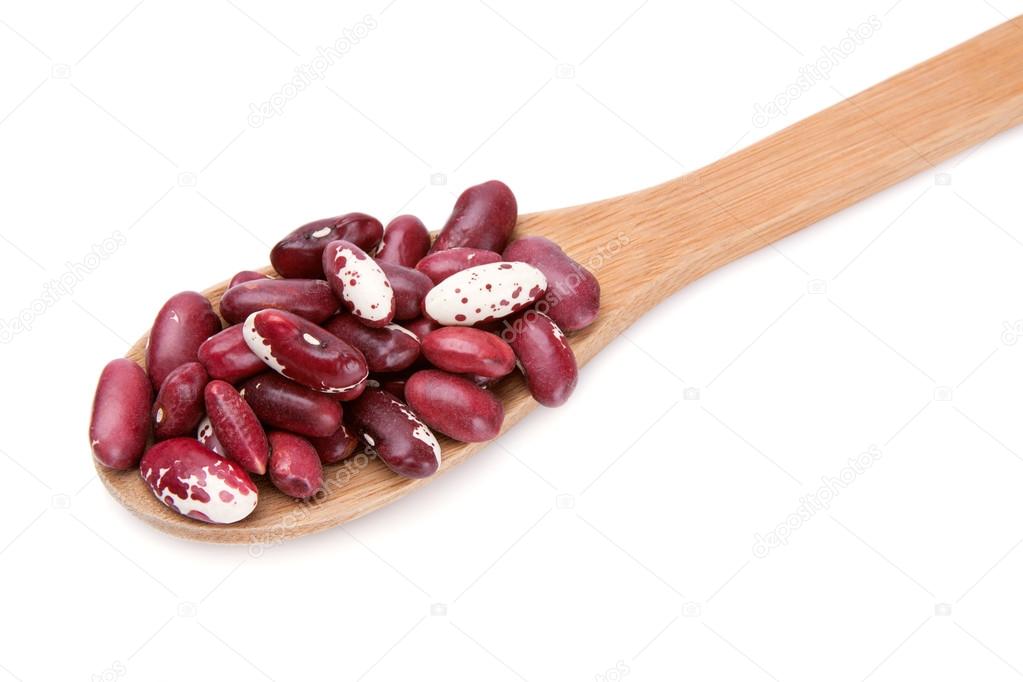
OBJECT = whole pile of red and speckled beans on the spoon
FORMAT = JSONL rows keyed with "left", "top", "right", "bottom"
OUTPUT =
{"left": 89, "top": 180, "right": 601, "bottom": 524}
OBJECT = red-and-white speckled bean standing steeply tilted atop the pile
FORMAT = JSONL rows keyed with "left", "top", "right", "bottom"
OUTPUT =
{"left": 323, "top": 239, "right": 395, "bottom": 327}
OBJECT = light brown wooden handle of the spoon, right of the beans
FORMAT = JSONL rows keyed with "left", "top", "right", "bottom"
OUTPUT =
{"left": 521, "top": 18, "right": 1023, "bottom": 331}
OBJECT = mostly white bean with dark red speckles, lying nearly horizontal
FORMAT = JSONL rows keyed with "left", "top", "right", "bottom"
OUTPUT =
{"left": 422, "top": 262, "right": 547, "bottom": 326}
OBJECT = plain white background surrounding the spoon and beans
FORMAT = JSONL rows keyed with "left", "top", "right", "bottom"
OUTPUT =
{"left": 0, "top": 0, "right": 1023, "bottom": 681}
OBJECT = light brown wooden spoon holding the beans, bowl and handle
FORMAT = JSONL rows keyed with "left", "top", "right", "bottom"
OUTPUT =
{"left": 97, "top": 17, "right": 1023, "bottom": 544}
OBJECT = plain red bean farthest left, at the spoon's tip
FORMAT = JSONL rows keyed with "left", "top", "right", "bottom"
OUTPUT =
{"left": 89, "top": 358, "right": 152, "bottom": 469}
